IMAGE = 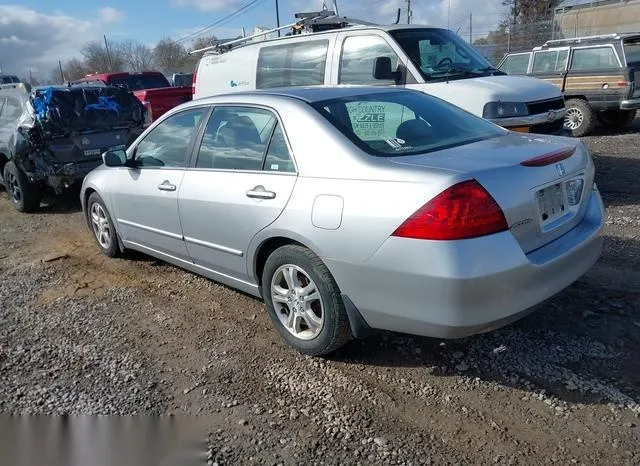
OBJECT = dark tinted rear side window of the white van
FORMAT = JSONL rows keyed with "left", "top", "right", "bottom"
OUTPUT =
{"left": 256, "top": 40, "right": 329, "bottom": 89}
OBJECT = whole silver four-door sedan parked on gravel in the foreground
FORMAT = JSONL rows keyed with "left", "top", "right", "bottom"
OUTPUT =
{"left": 81, "top": 87, "right": 604, "bottom": 355}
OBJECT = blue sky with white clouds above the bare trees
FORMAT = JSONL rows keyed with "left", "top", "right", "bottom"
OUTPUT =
{"left": 0, "top": 0, "right": 504, "bottom": 77}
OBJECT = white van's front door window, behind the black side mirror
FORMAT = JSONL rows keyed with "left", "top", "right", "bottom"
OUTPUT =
{"left": 339, "top": 36, "right": 398, "bottom": 85}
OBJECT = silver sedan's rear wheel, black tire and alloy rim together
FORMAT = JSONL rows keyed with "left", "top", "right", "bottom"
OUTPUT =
{"left": 262, "top": 245, "right": 351, "bottom": 356}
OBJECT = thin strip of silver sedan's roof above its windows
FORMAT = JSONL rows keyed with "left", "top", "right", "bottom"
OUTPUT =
{"left": 193, "top": 86, "right": 418, "bottom": 104}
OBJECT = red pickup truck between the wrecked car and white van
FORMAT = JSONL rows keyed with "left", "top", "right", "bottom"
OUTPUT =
{"left": 71, "top": 71, "right": 193, "bottom": 121}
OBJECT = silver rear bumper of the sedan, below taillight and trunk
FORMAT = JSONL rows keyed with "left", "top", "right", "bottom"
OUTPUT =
{"left": 325, "top": 190, "right": 604, "bottom": 338}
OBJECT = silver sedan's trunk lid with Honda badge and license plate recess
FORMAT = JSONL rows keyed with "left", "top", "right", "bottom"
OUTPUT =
{"left": 391, "top": 133, "right": 594, "bottom": 253}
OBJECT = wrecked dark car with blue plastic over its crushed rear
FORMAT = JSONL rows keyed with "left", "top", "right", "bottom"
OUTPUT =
{"left": 0, "top": 86, "right": 149, "bottom": 212}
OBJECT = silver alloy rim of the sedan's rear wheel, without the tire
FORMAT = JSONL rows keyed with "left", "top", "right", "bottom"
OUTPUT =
{"left": 271, "top": 264, "right": 325, "bottom": 340}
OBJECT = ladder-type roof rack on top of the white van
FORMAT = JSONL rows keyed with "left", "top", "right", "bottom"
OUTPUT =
{"left": 189, "top": 10, "right": 377, "bottom": 54}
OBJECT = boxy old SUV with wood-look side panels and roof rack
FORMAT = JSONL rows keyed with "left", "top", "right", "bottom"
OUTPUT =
{"left": 498, "top": 34, "right": 640, "bottom": 136}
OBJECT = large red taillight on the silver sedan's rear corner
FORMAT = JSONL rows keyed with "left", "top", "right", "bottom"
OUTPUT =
{"left": 393, "top": 180, "right": 509, "bottom": 240}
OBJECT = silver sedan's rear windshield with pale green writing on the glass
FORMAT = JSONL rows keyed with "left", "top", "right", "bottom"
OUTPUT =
{"left": 313, "top": 91, "right": 506, "bottom": 157}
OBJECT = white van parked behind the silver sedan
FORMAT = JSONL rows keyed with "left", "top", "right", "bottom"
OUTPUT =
{"left": 194, "top": 25, "right": 565, "bottom": 134}
